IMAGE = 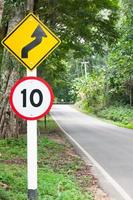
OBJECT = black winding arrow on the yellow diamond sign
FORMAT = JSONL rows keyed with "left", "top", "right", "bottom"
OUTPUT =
{"left": 21, "top": 25, "right": 47, "bottom": 58}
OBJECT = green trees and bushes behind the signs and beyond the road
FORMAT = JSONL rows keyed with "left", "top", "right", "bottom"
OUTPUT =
{"left": 0, "top": 0, "right": 133, "bottom": 138}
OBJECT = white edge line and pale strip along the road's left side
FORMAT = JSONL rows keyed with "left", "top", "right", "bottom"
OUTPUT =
{"left": 50, "top": 112, "right": 132, "bottom": 200}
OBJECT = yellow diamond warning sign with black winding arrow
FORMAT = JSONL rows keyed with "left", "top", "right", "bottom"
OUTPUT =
{"left": 2, "top": 13, "right": 61, "bottom": 70}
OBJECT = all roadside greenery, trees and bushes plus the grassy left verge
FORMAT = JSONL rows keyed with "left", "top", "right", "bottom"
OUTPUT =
{"left": 0, "top": 0, "right": 133, "bottom": 200}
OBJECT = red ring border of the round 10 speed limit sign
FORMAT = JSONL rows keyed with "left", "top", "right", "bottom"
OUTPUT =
{"left": 9, "top": 76, "right": 54, "bottom": 120}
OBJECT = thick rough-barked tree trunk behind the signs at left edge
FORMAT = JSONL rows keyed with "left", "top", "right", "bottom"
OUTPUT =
{"left": 0, "top": 5, "right": 23, "bottom": 138}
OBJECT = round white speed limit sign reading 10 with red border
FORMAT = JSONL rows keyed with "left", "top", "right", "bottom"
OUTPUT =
{"left": 10, "top": 77, "right": 54, "bottom": 120}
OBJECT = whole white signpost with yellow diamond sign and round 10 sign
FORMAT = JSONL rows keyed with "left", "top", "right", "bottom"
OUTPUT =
{"left": 2, "top": 13, "right": 61, "bottom": 200}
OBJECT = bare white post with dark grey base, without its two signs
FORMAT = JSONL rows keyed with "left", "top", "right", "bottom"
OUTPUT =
{"left": 27, "top": 69, "right": 37, "bottom": 200}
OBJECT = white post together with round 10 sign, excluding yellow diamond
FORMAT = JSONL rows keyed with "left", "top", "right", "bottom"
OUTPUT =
{"left": 10, "top": 75, "right": 54, "bottom": 200}
